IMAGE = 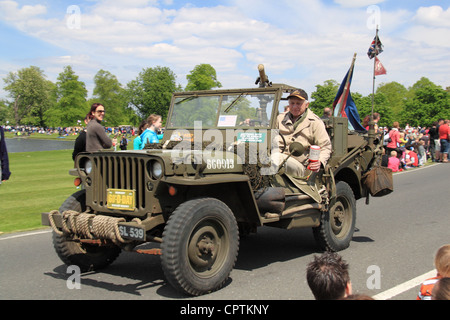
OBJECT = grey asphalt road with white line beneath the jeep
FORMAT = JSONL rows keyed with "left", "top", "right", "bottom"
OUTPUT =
{"left": 0, "top": 164, "right": 450, "bottom": 302}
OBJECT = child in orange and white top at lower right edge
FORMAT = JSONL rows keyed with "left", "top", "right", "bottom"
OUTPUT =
{"left": 416, "top": 244, "right": 450, "bottom": 300}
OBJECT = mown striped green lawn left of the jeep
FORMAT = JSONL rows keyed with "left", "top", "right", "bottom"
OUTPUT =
{"left": 0, "top": 150, "right": 77, "bottom": 233}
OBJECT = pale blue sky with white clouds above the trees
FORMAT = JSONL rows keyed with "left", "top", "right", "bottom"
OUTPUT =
{"left": 0, "top": 0, "right": 450, "bottom": 98}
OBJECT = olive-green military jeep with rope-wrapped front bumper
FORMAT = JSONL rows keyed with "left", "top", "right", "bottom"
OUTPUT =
{"left": 42, "top": 68, "right": 381, "bottom": 295}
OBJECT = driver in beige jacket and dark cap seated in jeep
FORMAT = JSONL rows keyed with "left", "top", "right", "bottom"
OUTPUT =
{"left": 272, "top": 89, "right": 331, "bottom": 177}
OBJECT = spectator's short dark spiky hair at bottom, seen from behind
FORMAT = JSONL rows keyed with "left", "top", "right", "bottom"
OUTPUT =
{"left": 306, "top": 252, "right": 350, "bottom": 300}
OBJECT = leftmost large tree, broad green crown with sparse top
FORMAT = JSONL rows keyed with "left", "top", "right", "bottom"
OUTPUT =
{"left": 4, "top": 66, "right": 53, "bottom": 126}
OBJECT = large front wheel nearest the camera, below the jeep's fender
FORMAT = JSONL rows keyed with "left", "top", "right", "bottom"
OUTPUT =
{"left": 161, "top": 198, "right": 239, "bottom": 296}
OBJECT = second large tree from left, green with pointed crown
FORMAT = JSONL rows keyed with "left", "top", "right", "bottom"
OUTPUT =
{"left": 46, "top": 66, "right": 89, "bottom": 127}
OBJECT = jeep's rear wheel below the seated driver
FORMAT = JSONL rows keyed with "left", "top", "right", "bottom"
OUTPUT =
{"left": 313, "top": 181, "right": 356, "bottom": 251}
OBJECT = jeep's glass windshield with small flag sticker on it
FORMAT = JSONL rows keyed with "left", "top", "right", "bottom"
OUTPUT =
{"left": 167, "top": 92, "right": 275, "bottom": 129}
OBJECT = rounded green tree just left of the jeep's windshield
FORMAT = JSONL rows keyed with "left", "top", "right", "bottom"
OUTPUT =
{"left": 126, "top": 66, "right": 177, "bottom": 119}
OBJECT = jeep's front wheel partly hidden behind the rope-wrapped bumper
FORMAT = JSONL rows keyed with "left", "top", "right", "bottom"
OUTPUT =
{"left": 53, "top": 190, "right": 121, "bottom": 272}
